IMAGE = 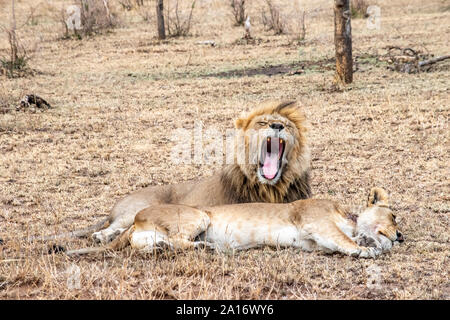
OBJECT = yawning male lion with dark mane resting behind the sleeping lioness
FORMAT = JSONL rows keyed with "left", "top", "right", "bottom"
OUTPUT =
{"left": 37, "top": 101, "right": 311, "bottom": 243}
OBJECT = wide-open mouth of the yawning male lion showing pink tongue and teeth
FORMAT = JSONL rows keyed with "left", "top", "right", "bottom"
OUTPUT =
{"left": 259, "top": 137, "right": 286, "bottom": 180}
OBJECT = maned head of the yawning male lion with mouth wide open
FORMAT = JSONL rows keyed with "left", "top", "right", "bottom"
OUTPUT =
{"left": 236, "top": 101, "right": 309, "bottom": 185}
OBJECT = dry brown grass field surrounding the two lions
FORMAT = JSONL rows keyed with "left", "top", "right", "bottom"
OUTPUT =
{"left": 0, "top": 0, "right": 450, "bottom": 299}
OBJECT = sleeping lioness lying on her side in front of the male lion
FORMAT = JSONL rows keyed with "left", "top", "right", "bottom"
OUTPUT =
{"left": 67, "top": 188, "right": 403, "bottom": 258}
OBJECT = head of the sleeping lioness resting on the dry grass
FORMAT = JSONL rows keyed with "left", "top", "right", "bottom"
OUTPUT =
{"left": 357, "top": 188, "right": 404, "bottom": 251}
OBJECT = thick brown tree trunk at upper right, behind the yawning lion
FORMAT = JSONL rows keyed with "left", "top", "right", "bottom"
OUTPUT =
{"left": 334, "top": 0, "right": 353, "bottom": 84}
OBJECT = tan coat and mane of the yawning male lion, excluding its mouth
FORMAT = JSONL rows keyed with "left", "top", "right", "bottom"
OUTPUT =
{"left": 89, "top": 101, "right": 311, "bottom": 243}
